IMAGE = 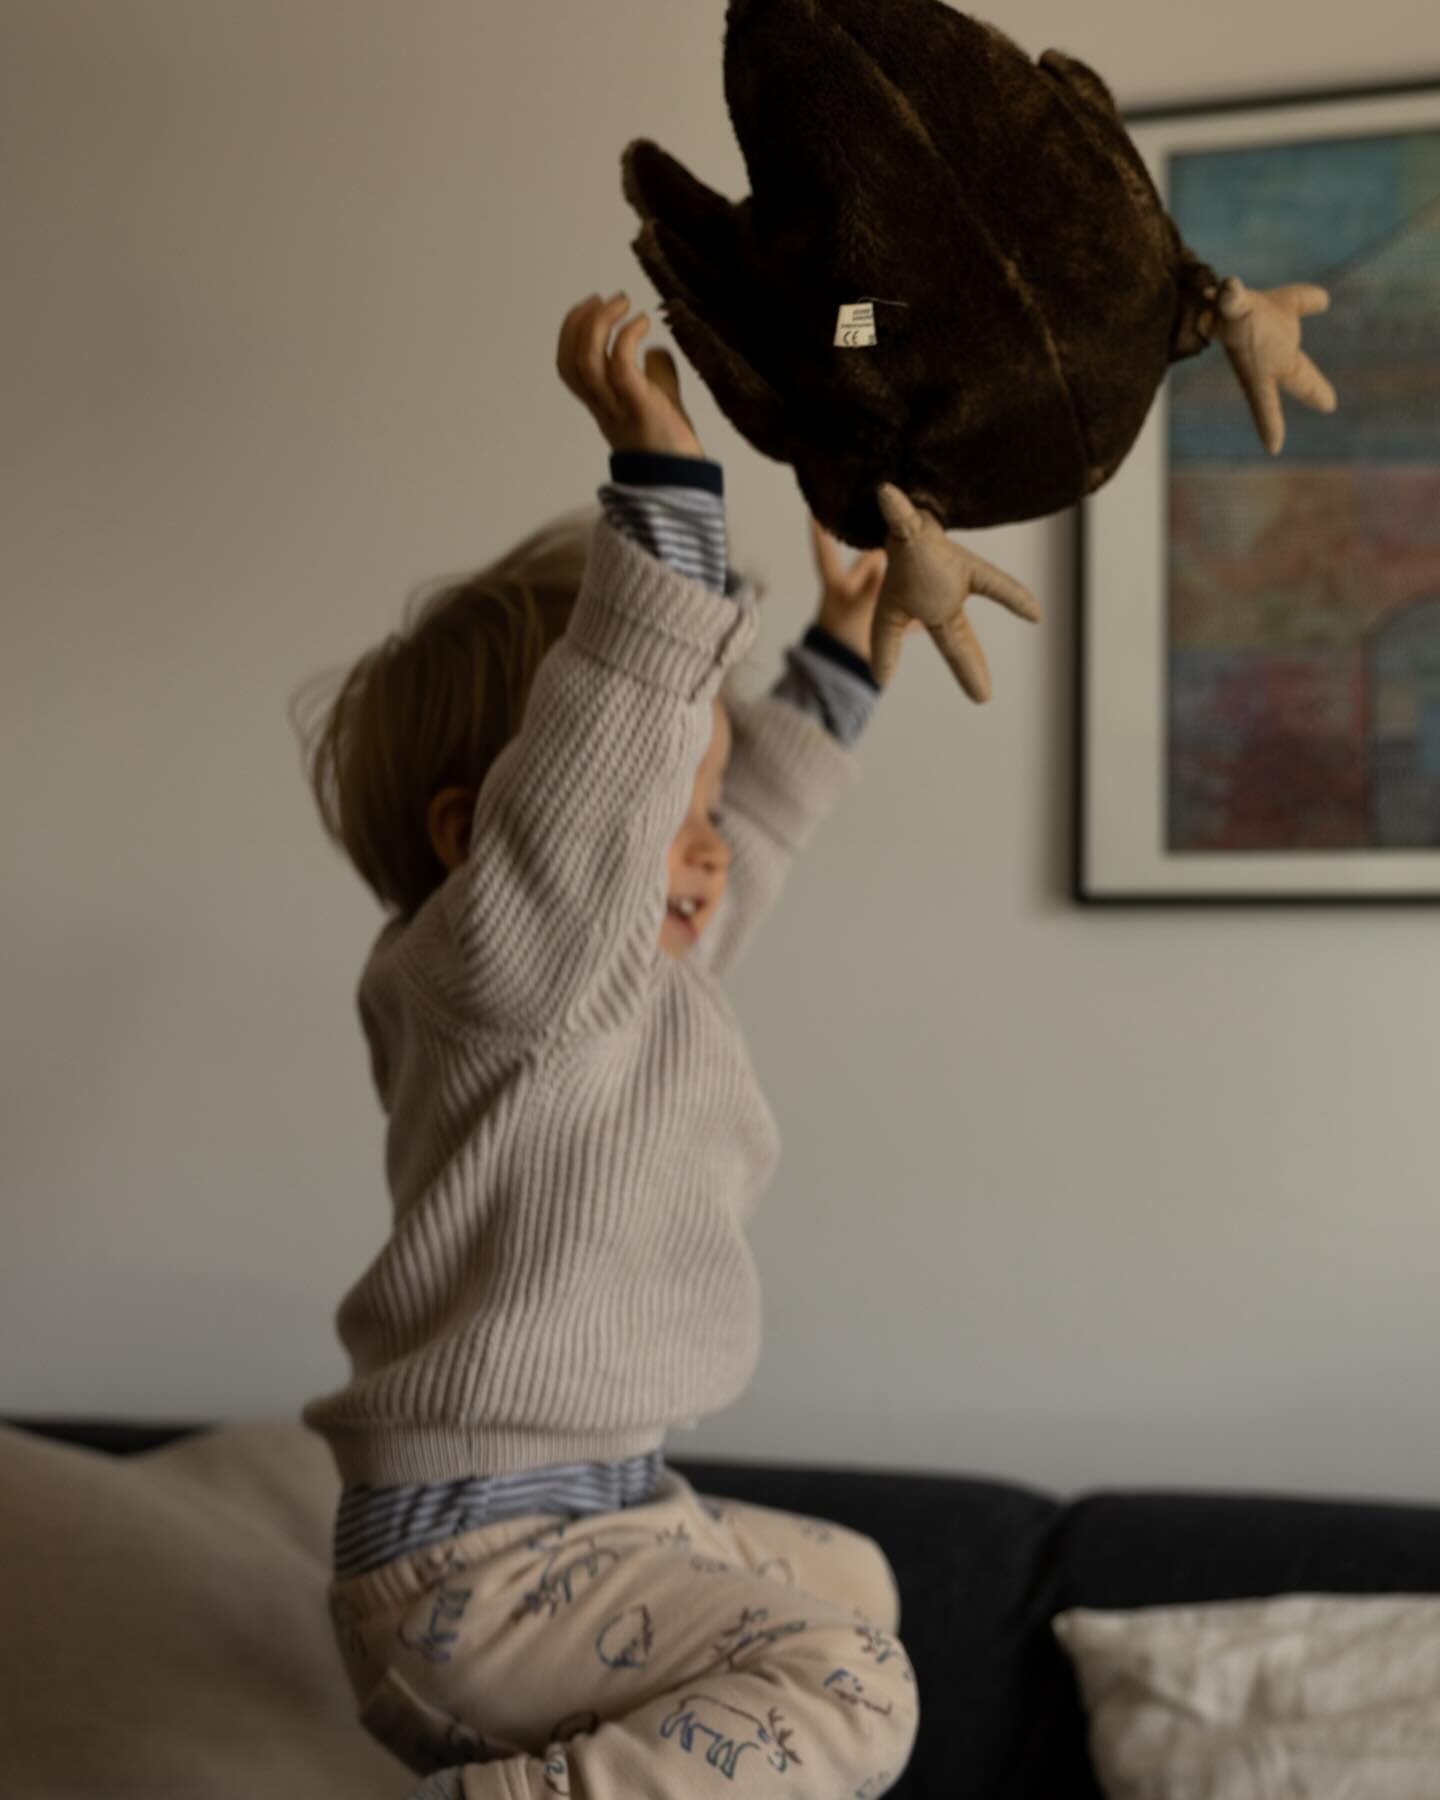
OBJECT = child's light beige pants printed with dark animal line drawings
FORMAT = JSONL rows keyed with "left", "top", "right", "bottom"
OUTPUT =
{"left": 331, "top": 1469, "right": 918, "bottom": 1800}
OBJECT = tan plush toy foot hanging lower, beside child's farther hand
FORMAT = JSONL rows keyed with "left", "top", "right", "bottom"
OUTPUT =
{"left": 869, "top": 482, "right": 1040, "bottom": 702}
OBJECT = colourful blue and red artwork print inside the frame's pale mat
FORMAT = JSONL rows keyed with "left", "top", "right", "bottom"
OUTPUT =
{"left": 1165, "top": 130, "right": 1440, "bottom": 853}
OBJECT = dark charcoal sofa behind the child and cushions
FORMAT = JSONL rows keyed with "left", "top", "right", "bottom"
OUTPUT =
{"left": 11, "top": 1418, "right": 1440, "bottom": 1800}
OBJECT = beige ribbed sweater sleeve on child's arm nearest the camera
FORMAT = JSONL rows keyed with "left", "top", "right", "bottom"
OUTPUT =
{"left": 403, "top": 518, "right": 758, "bottom": 1037}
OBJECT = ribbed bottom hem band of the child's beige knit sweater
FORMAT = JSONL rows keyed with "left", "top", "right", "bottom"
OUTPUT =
{"left": 306, "top": 1420, "right": 664, "bottom": 1487}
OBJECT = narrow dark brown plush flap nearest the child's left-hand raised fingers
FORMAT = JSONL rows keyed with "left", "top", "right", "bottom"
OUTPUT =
{"left": 621, "top": 139, "right": 794, "bottom": 463}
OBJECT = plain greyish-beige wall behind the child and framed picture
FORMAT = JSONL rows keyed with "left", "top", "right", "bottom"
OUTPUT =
{"left": 0, "top": 0, "right": 1440, "bottom": 1498}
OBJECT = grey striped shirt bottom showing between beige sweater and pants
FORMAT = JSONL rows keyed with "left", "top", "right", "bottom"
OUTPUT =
{"left": 335, "top": 1451, "right": 664, "bottom": 1577}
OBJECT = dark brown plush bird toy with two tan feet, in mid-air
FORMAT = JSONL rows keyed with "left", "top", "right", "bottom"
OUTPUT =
{"left": 623, "top": 0, "right": 1336, "bottom": 700}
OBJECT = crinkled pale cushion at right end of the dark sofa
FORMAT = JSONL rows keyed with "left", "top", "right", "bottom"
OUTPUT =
{"left": 1055, "top": 1595, "right": 1440, "bottom": 1800}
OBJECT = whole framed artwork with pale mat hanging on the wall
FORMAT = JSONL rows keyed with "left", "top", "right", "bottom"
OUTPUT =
{"left": 1075, "top": 79, "right": 1440, "bottom": 904}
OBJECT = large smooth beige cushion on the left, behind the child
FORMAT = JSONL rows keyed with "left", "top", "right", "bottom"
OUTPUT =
{"left": 0, "top": 1422, "right": 405, "bottom": 1800}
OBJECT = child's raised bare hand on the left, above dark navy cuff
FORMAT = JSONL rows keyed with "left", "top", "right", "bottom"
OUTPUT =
{"left": 556, "top": 293, "right": 706, "bottom": 455}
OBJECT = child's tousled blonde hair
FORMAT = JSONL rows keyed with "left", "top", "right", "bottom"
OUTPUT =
{"left": 290, "top": 506, "right": 765, "bottom": 918}
